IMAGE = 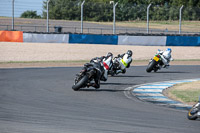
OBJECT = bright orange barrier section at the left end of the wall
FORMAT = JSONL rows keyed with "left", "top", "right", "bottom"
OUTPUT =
{"left": 0, "top": 31, "right": 23, "bottom": 42}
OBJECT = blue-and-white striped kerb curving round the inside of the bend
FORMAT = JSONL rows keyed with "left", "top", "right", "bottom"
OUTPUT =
{"left": 125, "top": 78, "right": 200, "bottom": 110}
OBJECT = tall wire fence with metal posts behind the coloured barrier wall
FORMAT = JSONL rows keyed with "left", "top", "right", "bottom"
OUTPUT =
{"left": 0, "top": 0, "right": 200, "bottom": 34}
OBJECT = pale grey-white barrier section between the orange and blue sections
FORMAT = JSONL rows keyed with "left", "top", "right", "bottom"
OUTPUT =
{"left": 23, "top": 33, "right": 69, "bottom": 43}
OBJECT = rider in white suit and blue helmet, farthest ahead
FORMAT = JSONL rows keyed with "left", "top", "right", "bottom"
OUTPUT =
{"left": 157, "top": 48, "right": 174, "bottom": 69}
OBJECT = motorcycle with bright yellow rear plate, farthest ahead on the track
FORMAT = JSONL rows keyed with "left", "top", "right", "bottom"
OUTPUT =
{"left": 146, "top": 53, "right": 164, "bottom": 72}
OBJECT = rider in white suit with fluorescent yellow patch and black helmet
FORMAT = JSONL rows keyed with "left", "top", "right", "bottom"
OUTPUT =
{"left": 114, "top": 50, "right": 133, "bottom": 74}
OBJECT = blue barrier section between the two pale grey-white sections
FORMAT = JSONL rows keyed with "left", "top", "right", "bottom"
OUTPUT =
{"left": 69, "top": 34, "right": 118, "bottom": 45}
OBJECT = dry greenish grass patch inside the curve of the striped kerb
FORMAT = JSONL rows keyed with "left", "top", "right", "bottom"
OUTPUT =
{"left": 171, "top": 90, "right": 200, "bottom": 102}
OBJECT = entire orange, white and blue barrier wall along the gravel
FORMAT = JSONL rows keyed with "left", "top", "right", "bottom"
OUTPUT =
{"left": 0, "top": 31, "right": 200, "bottom": 46}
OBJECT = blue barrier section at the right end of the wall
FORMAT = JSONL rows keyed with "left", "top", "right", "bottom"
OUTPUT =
{"left": 166, "top": 36, "right": 200, "bottom": 46}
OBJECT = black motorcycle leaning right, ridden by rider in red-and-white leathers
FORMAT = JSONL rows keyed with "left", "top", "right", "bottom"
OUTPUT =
{"left": 72, "top": 63, "right": 99, "bottom": 91}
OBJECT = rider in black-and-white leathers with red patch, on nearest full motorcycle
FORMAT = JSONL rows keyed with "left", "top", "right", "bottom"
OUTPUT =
{"left": 87, "top": 52, "right": 113, "bottom": 88}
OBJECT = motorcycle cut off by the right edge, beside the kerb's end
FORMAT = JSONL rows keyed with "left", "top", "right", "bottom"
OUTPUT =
{"left": 187, "top": 97, "right": 200, "bottom": 120}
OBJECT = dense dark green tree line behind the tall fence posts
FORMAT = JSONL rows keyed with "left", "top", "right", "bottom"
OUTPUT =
{"left": 21, "top": 0, "right": 200, "bottom": 22}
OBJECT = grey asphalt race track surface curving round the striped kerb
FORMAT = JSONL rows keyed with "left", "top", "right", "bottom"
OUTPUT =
{"left": 0, "top": 66, "right": 200, "bottom": 133}
